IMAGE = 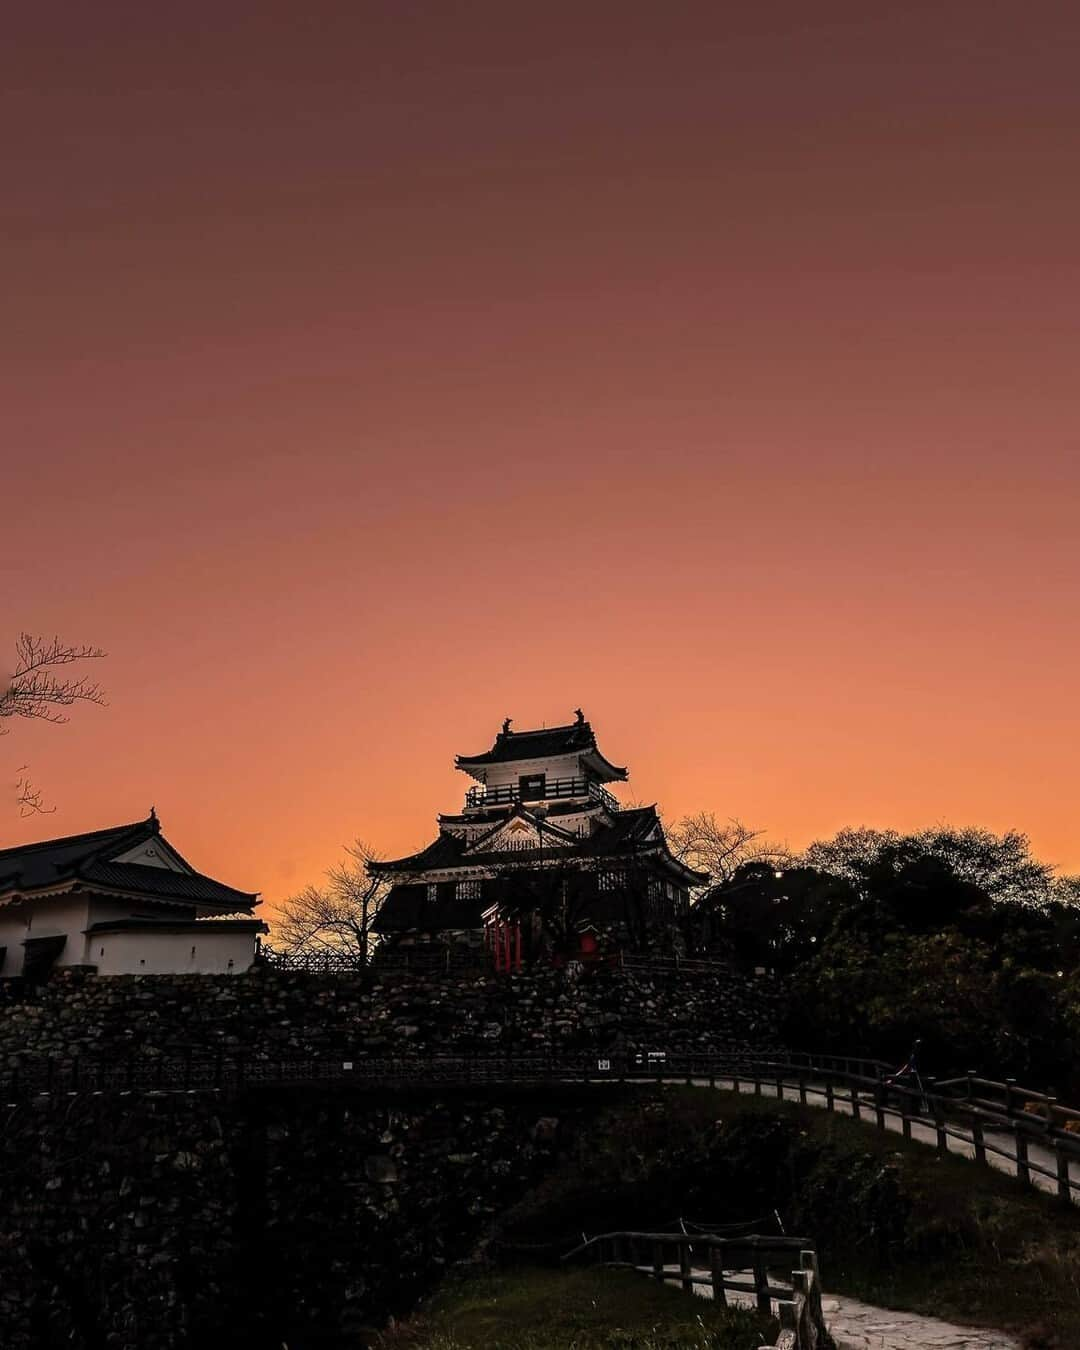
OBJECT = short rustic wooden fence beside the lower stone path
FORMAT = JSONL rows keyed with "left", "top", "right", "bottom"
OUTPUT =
{"left": 563, "top": 1233, "right": 830, "bottom": 1350}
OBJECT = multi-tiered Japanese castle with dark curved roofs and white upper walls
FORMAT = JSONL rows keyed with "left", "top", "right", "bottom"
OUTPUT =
{"left": 370, "top": 709, "right": 709, "bottom": 965}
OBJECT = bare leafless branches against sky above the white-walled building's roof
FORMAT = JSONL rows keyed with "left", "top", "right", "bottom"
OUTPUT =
{"left": 0, "top": 633, "right": 105, "bottom": 815}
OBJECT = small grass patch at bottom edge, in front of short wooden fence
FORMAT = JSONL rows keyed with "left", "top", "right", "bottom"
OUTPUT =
{"left": 377, "top": 1268, "right": 776, "bottom": 1350}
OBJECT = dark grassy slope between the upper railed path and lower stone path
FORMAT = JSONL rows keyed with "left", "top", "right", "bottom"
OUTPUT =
{"left": 488, "top": 1088, "right": 1080, "bottom": 1350}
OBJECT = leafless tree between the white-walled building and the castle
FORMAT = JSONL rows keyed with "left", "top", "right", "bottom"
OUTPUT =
{"left": 271, "top": 840, "right": 390, "bottom": 961}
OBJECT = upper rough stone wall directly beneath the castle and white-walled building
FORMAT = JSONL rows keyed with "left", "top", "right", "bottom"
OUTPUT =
{"left": 0, "top": 968, "right": 779, "bottom": 1071}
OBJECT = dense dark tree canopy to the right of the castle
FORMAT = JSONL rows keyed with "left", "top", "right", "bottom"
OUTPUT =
{"left": 694, "top": 826, "right": 1080, "bottom": 1099}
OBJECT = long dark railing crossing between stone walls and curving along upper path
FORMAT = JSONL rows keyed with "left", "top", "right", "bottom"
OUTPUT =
{"left": 0, "top": 1049, "right": 1080, "bottom": 1199}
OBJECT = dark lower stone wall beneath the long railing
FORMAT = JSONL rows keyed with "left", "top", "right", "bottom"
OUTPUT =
{"left": 0, "top": 1087, "right": 577, "bottom": 1350}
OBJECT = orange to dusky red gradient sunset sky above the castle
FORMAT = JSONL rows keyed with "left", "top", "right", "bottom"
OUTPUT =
{"left": 0, "top": 0, "right": 1080, "bottom": 905}
